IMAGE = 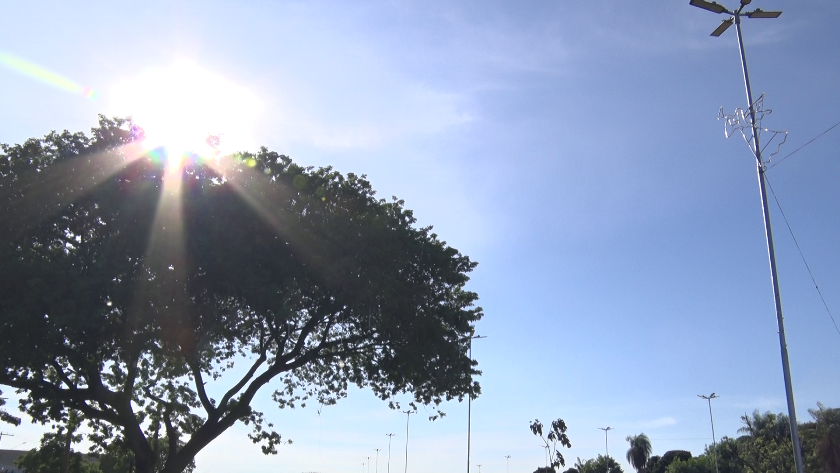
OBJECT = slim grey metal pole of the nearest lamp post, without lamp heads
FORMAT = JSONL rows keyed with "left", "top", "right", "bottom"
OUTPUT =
{"left": 735, "top": 12, "right": 804, "bottom": 473}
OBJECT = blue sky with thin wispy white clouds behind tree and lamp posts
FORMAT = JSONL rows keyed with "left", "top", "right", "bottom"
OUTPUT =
{"left": 0, "top": 0, "right": 840, "bottom": 473}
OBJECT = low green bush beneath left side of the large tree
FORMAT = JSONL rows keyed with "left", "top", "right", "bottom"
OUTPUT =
{"left": 15, "top": 429, "right": 100, "bottom": 473}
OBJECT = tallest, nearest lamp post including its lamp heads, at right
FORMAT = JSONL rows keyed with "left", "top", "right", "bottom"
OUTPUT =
{"left": 689, "top": 0, "right": 804, "bottom": 473}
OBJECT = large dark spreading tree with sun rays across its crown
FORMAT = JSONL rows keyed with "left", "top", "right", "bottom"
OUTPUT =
{"left": 0, "top": 118, "right": 481, "bottom": 473}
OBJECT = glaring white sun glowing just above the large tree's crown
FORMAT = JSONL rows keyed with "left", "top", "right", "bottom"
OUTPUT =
{"left": 110, "top": 61, "right": 258, "bottom": 161}
